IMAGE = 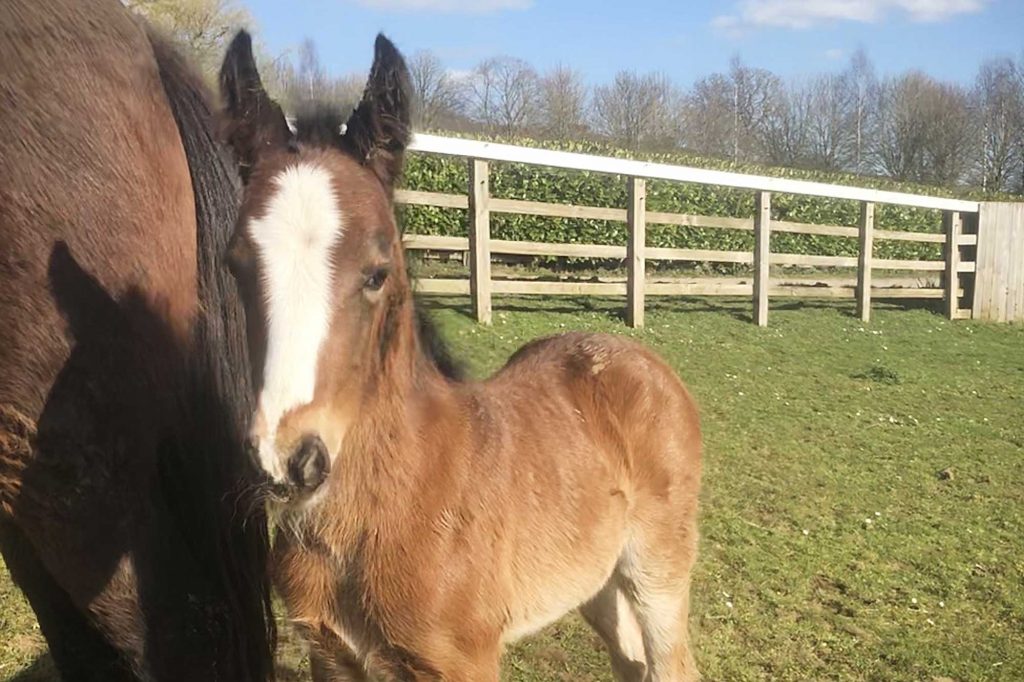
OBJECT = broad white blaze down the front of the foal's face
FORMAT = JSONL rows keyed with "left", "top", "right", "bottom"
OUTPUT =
{"left": 249, "top": 164, "right": 343, "bottom": 479}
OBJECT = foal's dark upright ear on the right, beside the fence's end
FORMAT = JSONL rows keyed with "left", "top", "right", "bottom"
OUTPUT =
{"left": 341, "top": 35, "right": 412, "bottom": 186}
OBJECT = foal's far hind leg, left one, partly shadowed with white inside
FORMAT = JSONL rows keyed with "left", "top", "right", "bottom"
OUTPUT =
{"left": 580, "top": 576, "right": 647, "bottom": 682}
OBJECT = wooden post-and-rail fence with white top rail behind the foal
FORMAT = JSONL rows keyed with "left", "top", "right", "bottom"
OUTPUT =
{"left": 395, "top": 135, "right": 1024, "bottom": 327}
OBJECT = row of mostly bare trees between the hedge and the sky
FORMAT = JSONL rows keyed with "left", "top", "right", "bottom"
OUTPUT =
{"left": 128, "top": 0, "right": 1024, "bottom": 194}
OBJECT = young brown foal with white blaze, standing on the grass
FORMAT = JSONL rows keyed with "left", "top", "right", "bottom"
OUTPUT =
{"left": 221, "top": 34, "right": 700, "bottom": 682}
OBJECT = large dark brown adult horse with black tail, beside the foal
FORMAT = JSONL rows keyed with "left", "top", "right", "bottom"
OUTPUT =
{"left": 0, "top": 0, "right": 272, "bottom": 682}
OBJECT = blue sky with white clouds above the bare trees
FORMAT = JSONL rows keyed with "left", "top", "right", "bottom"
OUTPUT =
{"left": 243, "top": 0, "right": 1024, "bottom": 86}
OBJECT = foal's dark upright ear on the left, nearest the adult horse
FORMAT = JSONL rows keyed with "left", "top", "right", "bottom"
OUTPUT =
{"left": 220, "top": 31, "right": 292, "bottom": 181}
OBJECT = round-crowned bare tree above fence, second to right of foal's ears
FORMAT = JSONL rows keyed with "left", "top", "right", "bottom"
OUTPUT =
{"left": 466, "top": 56, "right": 540, "bottom": 136}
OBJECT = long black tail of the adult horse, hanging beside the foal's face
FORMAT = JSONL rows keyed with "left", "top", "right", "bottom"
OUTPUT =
{"left": 150, "top": 31, "right": 275, "bottom": 682}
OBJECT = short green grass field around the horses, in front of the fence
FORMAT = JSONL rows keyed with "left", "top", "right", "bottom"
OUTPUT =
{"left": 0, "top": 299, "right": 1024, "bottom": 682}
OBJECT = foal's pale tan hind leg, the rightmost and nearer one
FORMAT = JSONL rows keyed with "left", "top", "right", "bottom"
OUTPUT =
{"left": 620, "top": 532, "right": 700, "bottom": 682}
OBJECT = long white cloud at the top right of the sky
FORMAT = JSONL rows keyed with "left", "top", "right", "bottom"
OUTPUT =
{"left": 712, "top": 0, "right": 989, "bottom": 32}
